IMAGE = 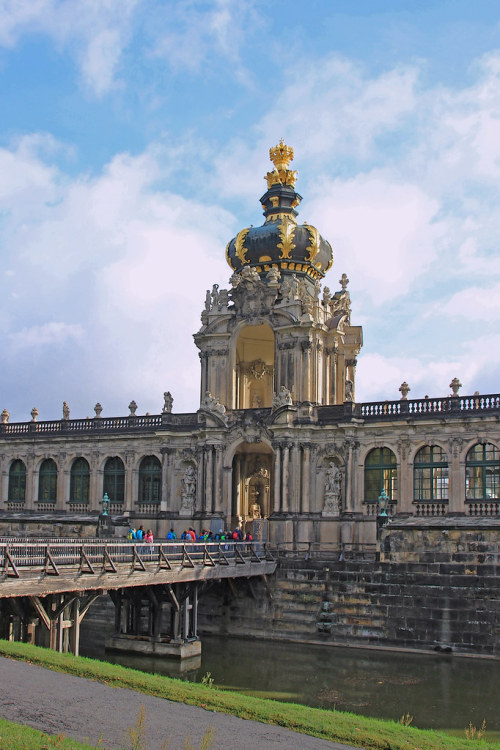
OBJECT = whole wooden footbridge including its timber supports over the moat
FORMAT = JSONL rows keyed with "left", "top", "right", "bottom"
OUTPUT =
{"left": 0, "top": 538, "right": 277, "bottom": 657}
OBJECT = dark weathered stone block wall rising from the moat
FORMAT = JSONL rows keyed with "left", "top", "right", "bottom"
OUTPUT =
{"left": 200, "top": 518, "right": 500, "bottom": 656}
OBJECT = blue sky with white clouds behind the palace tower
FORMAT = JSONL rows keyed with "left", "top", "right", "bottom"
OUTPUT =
{"left": 0, "top": 0, "right": 500, "bottom": 421}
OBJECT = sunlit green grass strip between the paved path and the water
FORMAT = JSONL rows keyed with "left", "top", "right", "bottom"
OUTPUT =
{"left": 0, "top": 640, "right": 500, "bottom": 750}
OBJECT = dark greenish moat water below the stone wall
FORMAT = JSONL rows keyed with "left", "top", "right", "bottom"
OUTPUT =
{"left": 82, "top": 636, "right": 500, "bottom": 741}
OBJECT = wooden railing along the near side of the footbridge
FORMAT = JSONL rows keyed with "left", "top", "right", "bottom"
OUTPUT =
{"left": 0, "top": 538, "right": 274, "bottom": 574}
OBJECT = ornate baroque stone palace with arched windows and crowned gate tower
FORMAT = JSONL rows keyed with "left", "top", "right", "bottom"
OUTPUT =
{"left": 0, "top": 142, "right": 500, "bottom": 544}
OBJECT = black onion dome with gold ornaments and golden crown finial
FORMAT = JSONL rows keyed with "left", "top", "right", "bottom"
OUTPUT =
{"left": 226, "top": 139, "right": 333, "bottom": 279}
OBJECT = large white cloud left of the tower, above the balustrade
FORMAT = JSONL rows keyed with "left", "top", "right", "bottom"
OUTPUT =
{"left": 0, "top": 133, "right": 234, "bottom": 418}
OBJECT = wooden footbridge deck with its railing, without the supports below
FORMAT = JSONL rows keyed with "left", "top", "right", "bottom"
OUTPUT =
{"left": 0, "top": 539, "right": 277, "bottom": 598}
